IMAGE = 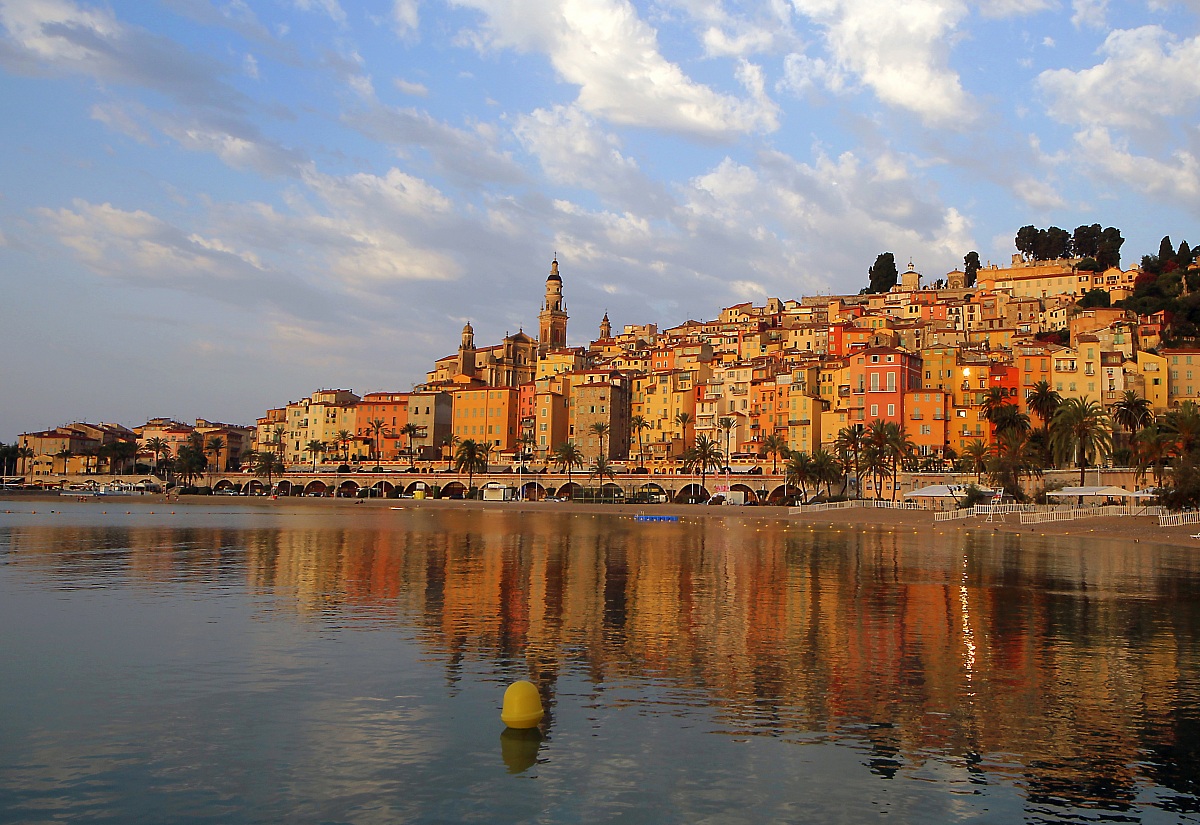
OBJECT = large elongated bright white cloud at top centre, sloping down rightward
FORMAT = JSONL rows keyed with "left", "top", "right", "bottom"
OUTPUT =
{"left": 457, "top": 0, "right": 778, "bottom": 138}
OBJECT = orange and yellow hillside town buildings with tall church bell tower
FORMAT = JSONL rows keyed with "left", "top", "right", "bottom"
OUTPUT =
{"left": 11, "top": 225, "right": 1200, "bottom": 498}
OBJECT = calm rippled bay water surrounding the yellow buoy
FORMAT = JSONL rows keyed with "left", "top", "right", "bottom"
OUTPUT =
{"left": 0, "top": 501, "right": 1200, "bottom": 824}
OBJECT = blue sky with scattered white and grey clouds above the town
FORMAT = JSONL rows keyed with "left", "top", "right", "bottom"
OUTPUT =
{"left": 0, "top": 0, "right": 1200, "bottom": 441}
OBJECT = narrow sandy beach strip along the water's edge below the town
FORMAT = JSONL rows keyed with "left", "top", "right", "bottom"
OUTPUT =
{"left": 0, "top": 490, "right": 1200, "bottom": 550}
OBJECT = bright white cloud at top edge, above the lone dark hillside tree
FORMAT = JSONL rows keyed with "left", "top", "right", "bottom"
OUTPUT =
{"left": 793, "top": 0, "right": 976, "bottom": 127}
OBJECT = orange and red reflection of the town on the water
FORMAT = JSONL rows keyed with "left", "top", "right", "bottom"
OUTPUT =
{"left": 0, "top": 510, "right": 1200, "bottom": 821}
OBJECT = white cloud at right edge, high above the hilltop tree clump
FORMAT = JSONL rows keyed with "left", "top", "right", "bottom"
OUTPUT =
{"left": 1038, "top": 25, "right": 1200, "bottom": 130}
